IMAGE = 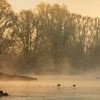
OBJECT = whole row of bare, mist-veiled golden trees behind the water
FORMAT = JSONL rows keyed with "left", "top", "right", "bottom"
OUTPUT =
{"left": 0, "top": 0, "right": 100, "bottom": 73}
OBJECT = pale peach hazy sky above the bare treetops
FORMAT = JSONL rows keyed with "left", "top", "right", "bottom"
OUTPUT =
{"left": 8, "top": 0, "right": 100, "bottom": 17}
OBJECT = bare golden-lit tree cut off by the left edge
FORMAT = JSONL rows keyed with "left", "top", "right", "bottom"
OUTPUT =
{"left": 0, "top": 0, "right": 13, "bottom": 55}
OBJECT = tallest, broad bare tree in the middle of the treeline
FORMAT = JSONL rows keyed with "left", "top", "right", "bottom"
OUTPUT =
{"left": 36, "top": 3, "right": 71, "bottom": 70}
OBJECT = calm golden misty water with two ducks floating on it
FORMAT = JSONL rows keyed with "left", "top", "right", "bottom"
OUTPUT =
{"left": 0, "top": 76, "right": 100, "bottom": 100}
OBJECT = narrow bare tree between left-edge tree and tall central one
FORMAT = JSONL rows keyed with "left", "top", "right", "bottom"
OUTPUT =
{"left": 11, "top": 10, "right": 36, "bottom": 71}
